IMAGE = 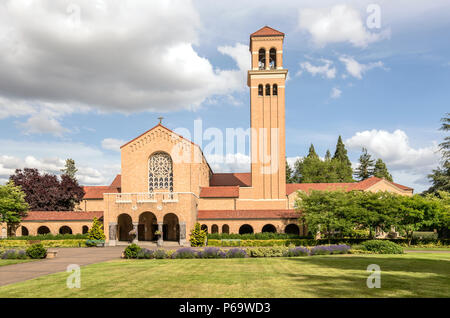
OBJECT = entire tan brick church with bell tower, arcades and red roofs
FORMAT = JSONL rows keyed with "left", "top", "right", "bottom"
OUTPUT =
{"left": 7, "top": 26, "right": 413, "bottom": 246}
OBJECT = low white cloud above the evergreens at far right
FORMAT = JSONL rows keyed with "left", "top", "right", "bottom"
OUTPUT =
{"left": 346, "top": 129, "right": 439, "bottom": 175}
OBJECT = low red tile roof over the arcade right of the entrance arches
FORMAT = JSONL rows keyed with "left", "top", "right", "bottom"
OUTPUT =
{"left": 198, "top": 210, "right": 300, "bottom": 220}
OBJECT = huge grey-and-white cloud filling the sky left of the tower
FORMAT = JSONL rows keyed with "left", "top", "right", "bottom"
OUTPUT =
{"left": 0, "top": 0, "right": 250, "bottom": 134}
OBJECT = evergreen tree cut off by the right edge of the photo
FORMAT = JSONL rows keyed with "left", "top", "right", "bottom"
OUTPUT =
{"left": 426, "top": 113, "right": 450, "bottom": 194}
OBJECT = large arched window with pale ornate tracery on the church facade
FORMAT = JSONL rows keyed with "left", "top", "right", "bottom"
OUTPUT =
{"left": 148, "top": 152, "right": 173, "bottom": 192}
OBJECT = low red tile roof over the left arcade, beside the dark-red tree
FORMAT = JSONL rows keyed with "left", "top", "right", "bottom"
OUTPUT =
{"left": 22, "top": 211, "right": 103, "bottom": 221}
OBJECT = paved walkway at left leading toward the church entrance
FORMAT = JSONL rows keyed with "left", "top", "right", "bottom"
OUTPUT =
{"left": 0, "top": 246, "right": 124, "bottom": 286}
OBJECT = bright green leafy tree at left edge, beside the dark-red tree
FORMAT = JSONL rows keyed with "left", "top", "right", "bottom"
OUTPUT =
{"left": 0, "top": 181, "right": 28, "bottom": 224}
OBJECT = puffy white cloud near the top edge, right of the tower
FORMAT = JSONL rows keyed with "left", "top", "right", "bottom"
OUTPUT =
{"left": 299, "top": 4, "right": 389, "bottom": 47}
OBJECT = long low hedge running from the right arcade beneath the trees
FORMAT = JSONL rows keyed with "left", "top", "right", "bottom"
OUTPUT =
{"left": 208, "top": 239, "right": 450, "bottom": 247}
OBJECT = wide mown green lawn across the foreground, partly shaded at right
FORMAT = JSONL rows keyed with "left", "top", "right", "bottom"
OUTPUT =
{"left": 0, "top": 253, "right": 450, "bottom": 298}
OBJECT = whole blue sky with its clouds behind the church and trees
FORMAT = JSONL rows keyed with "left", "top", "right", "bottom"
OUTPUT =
{"left": 0, "top": 0, "right": 450, "bottom": 192}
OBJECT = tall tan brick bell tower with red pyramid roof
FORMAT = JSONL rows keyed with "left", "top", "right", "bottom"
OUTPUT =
{"left": 247, "top": 26, "right": 288, "bottom": 200}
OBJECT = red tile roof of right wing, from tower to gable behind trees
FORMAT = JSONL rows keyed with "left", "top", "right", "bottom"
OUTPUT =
{"left": 286, "top": 177, "right": 414, "bottom": 194}
